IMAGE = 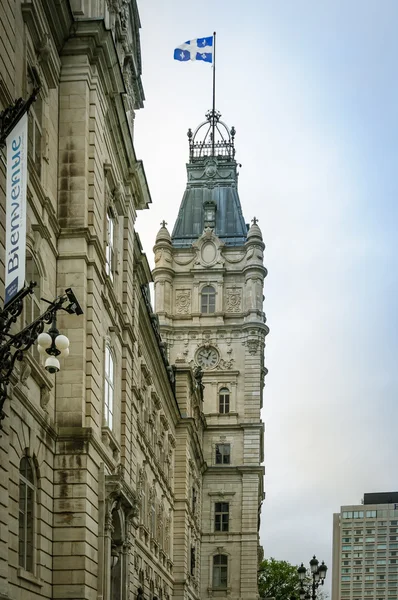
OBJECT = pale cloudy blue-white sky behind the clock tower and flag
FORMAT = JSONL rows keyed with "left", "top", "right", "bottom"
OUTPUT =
{"left": 135, "top": 0, "right": 398, "bottom": 580}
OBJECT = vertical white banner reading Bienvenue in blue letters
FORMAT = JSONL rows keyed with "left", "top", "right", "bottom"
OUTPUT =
{"left": 4, "top": 113, "right": 28, "bottom": 305}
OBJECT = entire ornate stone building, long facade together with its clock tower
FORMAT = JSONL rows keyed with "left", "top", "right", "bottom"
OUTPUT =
{"left": 0, "top": 0, "right": 268, "bottom": 600}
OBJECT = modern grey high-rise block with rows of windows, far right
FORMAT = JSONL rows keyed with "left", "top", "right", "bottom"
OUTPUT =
{"left": 332, "top": 492, "right": 398, "bottom": 600}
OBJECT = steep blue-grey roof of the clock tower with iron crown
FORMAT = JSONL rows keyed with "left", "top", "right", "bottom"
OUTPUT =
{"left": 171, "top": 111, "right": 247, "bottom": 248}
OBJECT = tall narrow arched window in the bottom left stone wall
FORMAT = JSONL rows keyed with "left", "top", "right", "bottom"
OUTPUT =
{"left": 18, "top": 456, "right": 36, "bottom": 572}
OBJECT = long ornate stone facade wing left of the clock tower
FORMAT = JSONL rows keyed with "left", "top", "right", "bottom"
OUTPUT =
{"left": 0, "top": 0, "right": 205, "bottom": 600}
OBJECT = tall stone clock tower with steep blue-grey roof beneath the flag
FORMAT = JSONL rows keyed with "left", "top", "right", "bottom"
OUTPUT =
{"left": 153, "top": 111, "right": 268, "bottom": 600}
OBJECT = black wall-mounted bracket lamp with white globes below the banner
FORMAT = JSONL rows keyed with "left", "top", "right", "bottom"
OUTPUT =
{"left": 0, "top": 281, "right": 83, "bottom": 429}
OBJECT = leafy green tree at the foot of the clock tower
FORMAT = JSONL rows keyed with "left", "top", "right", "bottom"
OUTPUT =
{"left": 258, "top": 558, "right": 300, "bottom": 600}
